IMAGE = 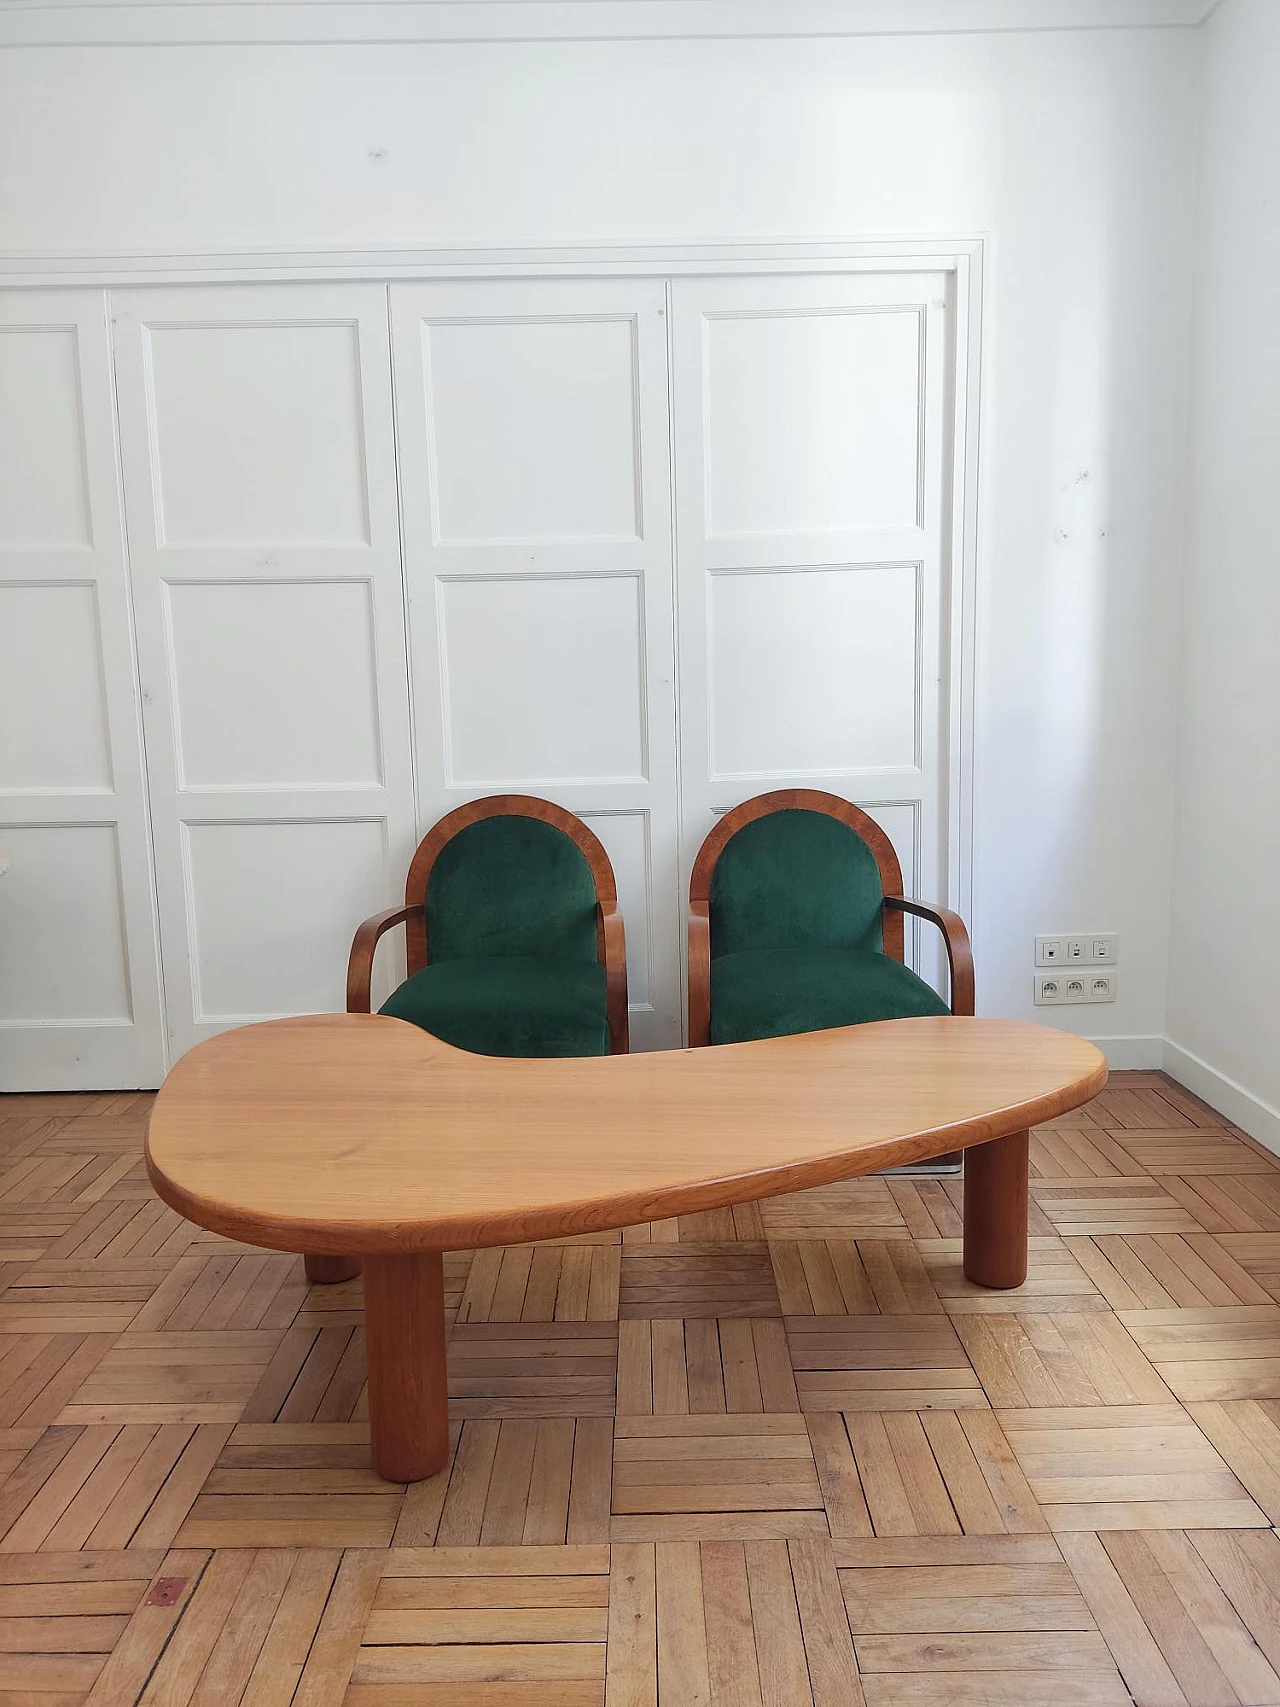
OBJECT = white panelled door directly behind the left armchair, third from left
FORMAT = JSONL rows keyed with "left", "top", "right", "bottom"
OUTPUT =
{"left": 391, "top": 280, "right": 679, "bottom": 1048}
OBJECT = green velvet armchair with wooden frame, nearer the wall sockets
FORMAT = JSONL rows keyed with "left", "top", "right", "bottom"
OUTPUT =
{"left": 689, "top": 789, "right": 973, "bottom": 1046}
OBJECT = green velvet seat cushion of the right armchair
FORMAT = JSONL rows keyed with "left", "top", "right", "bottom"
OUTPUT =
{"left": 712, "top": 947, "right": 951, "bottom": 1043}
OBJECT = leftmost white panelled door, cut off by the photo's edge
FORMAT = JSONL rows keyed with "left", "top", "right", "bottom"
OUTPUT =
{"left": 0, "top": 290, "right": 164, "bottom": 1091}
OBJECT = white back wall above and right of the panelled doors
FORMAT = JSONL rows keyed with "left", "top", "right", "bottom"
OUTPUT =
{"left": 0, "top": 20, "right": 1198, "bottom": 1065}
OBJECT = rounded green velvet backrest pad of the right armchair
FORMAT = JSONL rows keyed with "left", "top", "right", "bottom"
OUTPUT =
{"left": 710, "top": 809, "right": 884, "bottom": 959}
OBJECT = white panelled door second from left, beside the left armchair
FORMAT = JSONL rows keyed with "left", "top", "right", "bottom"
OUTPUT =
{"left": 113, "top": 285, "right": 415, "bottom": 1057}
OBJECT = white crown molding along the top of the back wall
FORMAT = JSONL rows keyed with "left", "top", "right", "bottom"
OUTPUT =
{"left": 0, "top": 0, "right": 1215, "bottom": 48}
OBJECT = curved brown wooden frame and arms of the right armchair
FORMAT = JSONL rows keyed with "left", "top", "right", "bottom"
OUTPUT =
{"left": 689, "top": 789, "right": 973, "bottom": 1048}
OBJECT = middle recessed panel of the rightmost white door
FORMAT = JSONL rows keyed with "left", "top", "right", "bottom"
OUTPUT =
{"left": 708, "top": 563, "right": 920, "bottom": 777}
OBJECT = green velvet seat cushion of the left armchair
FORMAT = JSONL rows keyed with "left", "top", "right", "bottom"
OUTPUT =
{"left": 381, "top": 956, "right": 609, "bottom": 1055}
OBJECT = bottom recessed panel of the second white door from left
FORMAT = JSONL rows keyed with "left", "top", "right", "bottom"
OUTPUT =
{"left": 186, "top": 821, "right": 387, "bottom": 1024}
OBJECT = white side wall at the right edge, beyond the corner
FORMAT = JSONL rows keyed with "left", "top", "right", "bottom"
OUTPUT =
{"left": 1167, "top": 0, "right": 1280, "bottom": 1147}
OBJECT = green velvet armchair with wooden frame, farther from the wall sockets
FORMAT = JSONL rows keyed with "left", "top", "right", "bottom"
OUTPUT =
{"left": 346, "top": 794, "right": 628, "bottom": 1055}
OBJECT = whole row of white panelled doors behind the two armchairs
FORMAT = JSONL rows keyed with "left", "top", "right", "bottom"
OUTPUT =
{"left": 0, "top": 270, "right": 952, "bottom": 1089}
